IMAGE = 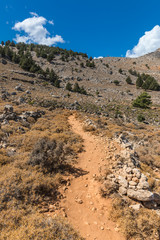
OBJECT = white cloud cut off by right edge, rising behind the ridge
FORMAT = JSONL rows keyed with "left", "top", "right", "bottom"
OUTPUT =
{"left": 126, "top": 25, "right": 160, "bottom": 58}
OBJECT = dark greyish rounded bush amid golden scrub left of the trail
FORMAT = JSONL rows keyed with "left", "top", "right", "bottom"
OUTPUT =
{"left": 28, "top": 138, "right": 71, "bottom": 173}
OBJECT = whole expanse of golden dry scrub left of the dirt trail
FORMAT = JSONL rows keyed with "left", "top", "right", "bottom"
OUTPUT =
{"left": 0, "top": 106, "right": 82, "bottom": 240}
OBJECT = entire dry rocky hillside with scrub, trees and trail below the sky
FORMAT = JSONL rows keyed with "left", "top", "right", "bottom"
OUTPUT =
{"left": 0, "top": 42, "right": 160, "bottom": 240}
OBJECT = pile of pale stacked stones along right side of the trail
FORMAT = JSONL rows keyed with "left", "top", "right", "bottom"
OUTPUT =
{"left": 107, "top": 135, "right": 160, "bottom": 207}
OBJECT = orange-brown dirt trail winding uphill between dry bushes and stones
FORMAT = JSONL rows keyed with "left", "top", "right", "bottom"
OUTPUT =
{"left": 61, "top": 115, "right": 124, "bottom": 240}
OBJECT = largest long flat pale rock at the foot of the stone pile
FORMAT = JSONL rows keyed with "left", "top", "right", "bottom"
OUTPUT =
{"left": 127, "top": 189, "right": 154, "bottom": 202}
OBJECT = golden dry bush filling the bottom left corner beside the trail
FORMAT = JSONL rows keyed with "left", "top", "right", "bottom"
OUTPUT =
{"left": 0, "top": 210, "right": 83, "bottom": 240}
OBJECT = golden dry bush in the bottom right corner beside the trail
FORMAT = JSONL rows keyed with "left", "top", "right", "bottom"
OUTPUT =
{"left": 111, "top": 198, "right": 160, "bottom": 240}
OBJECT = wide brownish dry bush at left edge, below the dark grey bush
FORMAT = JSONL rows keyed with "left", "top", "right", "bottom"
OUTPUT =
{"left": 0, "top": 168, "right": 59, "bottom": 211}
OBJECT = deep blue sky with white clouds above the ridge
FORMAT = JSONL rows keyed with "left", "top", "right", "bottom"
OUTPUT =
{"left": 0, "top": 0, "right": 160, "bottom": 57}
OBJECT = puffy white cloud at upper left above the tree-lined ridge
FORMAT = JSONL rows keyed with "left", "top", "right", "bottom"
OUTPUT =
{"left": 12, "top": 12, "right": 64, "bottom": 46}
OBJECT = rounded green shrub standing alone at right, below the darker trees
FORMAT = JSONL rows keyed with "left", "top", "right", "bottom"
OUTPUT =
{"left": 132, "top": 92, "right": 152, "bottom": 108}
